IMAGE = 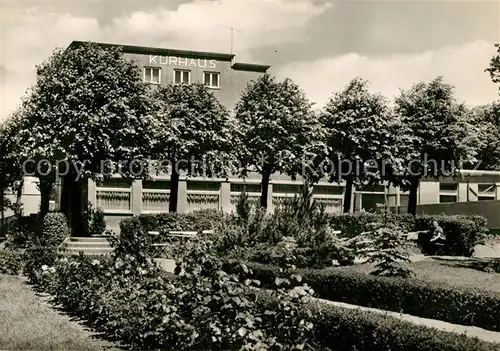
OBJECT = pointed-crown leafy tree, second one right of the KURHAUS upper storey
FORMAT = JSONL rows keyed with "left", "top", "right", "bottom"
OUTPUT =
{"left": 320, "top": 78, "right": 392, "bottom": 212}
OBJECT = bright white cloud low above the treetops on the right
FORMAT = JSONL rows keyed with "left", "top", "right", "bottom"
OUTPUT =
{"left": 274, "top": 40, "right": 498, "bottom": 106}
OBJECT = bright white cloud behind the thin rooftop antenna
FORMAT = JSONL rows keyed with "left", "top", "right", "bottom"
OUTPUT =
{"left": 107, "top": 1, "right": 332, "bottom": 58}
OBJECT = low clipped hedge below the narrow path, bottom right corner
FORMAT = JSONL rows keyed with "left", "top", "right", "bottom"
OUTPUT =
{"left": 257, "top": 291, "right": 500, "bottom": 351}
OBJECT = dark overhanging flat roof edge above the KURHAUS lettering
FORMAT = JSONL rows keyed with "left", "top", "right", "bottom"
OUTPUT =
{"left": 68, "top": 40, "right": 271, "bottom": 72}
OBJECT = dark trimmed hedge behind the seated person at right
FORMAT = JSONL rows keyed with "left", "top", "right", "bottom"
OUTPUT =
{"left": 330, "top": 213, "right": 488, "bottom": 256}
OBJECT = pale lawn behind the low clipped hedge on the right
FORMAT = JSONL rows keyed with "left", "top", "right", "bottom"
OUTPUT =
{"left": 329, "top": 260, "right": 500, "bottom": 292}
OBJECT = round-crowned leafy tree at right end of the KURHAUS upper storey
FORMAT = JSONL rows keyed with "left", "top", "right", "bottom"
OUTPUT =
{"left": 235, "top": 74, "right": 318, "bottom": 208}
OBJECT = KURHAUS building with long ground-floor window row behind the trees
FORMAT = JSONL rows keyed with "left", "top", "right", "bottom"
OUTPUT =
{"left": 4, "top": 41, "right": 500, "bottom": 234}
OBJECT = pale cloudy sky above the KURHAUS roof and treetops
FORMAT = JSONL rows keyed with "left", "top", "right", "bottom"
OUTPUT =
{"left": 0, "top": 0, "right": 500, "bottom": 121}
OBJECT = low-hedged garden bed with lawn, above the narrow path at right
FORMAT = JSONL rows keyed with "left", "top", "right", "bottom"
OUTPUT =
{"left": 226, "top": 261, "right": 500, "bottom": 331}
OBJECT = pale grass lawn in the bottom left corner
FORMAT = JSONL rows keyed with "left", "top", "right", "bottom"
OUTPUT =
{"left": 0, "top": 275, "right": 119, "bottom": 350}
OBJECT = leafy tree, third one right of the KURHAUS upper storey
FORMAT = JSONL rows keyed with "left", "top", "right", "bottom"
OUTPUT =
{"left": 391, "top": 77, "right": 475, "bottom": 215}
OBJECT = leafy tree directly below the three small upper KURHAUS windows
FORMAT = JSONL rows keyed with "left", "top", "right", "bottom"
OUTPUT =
{"left": 149, "top": 84, "right": 231, "bottom": 212}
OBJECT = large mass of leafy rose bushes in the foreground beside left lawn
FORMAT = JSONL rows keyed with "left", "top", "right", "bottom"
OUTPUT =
{"left": 39, "top": 220, "right": 320, "bottom": 350}
